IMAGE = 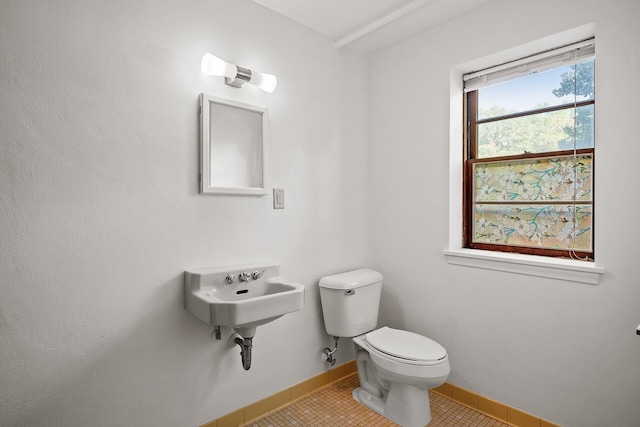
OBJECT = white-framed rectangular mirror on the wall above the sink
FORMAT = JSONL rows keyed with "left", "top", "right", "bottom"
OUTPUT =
{"left": 200, "top": 94, "right": 267, "bottom": 196}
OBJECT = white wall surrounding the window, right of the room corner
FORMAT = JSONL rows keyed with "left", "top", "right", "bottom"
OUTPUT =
{"left": 371, "top": 0, "right": 640, "bottom": 427}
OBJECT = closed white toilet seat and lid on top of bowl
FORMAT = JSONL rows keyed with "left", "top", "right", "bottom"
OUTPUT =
{"left": 365, "top": 326, "right": 447, "bottom": 365}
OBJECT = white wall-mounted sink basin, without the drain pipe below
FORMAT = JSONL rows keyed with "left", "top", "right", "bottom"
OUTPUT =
{"left": 185, "top": 263, "right": 304, "bottom": 334}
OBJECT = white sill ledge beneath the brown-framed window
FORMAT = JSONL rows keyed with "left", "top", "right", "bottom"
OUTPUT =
{"left": 442, "top": 249, "right": 604, "bottom": 285}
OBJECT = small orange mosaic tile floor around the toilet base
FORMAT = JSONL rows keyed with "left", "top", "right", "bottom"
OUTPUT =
{"left": 246, "top": 374, "right": 509, "bottom": 427}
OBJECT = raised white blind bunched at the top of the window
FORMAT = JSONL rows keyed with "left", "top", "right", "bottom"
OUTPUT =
{"left": 463, "top": 39, "right": 596, "bottom": 92}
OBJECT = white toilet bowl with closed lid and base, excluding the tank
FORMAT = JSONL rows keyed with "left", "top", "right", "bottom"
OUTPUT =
{"left": 353, "top": 326, "right": 451, "bottom": 427}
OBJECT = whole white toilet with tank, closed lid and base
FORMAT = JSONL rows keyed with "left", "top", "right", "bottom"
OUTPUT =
{"left": 320, "top": 268, "right": 451, "bottom": 427}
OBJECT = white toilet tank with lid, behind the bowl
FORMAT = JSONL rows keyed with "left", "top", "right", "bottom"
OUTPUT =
{"left": 319, "top": 268, "right": 382, "bottom": 337}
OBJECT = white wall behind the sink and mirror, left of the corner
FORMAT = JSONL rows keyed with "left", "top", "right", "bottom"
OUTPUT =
{"left": 0, "top": 0, "right": 372, "bottom": 427}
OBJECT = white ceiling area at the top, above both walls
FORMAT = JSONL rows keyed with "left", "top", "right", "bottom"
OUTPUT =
{"left": 253, "top": 0, "right": 496, "bottom": 52}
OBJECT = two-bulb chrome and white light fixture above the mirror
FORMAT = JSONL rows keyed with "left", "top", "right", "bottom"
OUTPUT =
{"left": 201, "top": 53, "right": 278, "bottom": 93}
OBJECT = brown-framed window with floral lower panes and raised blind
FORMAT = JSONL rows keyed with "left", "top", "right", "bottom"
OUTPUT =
{"left": 463, "top": 40, "right": 595, "bottom": 260}
